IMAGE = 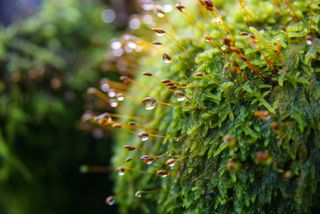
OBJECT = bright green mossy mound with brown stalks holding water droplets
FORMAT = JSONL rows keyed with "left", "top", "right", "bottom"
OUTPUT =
{"left": 91, "top": 0, "right": 320, "bottom": 213}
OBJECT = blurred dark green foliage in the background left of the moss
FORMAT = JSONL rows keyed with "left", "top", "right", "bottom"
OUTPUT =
{"left": 0, "top": 0, "right": 113, "bottom": 214}
